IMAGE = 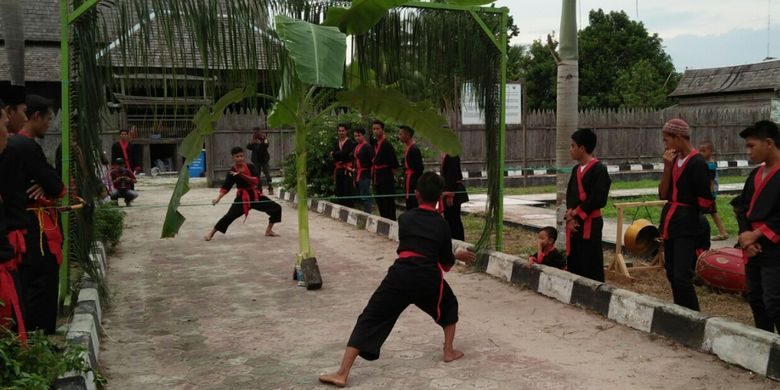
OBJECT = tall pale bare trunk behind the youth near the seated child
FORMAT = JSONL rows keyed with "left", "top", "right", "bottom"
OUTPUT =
{"left": 555, "top": 0, "right": 579, "bottom": 248}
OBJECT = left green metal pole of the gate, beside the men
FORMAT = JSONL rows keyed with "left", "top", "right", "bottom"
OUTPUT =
{"left": 59, "top": 0, "right": 70, "bottom": 305}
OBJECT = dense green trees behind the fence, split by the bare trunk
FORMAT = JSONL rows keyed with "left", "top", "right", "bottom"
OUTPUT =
{"left": 510, "top": 9, "right": 680, "bottom": 109}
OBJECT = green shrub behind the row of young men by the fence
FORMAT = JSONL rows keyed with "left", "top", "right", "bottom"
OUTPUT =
{"left": 282, "top": 112, "right": 434, "bottom": 196}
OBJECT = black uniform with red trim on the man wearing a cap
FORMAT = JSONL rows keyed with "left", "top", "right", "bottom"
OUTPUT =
{"left": 660, "top": 149, "right": 714, "bottom": 310}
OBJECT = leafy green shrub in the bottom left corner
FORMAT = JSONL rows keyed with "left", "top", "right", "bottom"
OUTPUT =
{"left": 0, "top": 328, "right": 104, "bottom": 390}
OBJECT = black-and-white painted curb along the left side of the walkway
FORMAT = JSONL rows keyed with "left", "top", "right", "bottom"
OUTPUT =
{"left": 52, "top": 242, "right": 107, "bottom": 390}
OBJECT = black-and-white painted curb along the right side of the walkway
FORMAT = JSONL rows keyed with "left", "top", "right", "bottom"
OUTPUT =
{"left": 279, "top": 190, "right": 780, "bottom": 380}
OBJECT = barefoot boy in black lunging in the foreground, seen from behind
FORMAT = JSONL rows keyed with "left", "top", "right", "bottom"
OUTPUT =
{"left": 319, "top": 172, "right": 476, "bottom": 387}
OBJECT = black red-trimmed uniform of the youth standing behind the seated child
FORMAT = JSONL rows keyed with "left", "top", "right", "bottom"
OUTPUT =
{"left": 566, "top": 158, "right": 612, "bottom": 282}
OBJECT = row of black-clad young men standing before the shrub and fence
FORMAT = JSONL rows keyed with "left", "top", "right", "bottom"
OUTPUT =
{"left": 331, "top": 120, "right": 468, "bottom": 240}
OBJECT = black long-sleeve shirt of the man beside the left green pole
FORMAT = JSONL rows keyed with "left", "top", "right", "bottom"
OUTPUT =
{"left": 0, "top": 134, "right": 65, "bottom": 231}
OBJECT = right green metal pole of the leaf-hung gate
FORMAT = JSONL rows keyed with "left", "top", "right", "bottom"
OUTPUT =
{"left": 496, "top": 8, "right": 509, "bottom": 251}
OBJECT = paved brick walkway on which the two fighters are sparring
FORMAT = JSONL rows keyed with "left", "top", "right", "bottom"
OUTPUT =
{"left": 101, "top": 181, "right": 777, "bottom": 390}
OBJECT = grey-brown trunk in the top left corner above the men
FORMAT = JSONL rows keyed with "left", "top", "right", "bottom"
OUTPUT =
{"left": 0, "top": 0, "right": 24, "bottom": 85}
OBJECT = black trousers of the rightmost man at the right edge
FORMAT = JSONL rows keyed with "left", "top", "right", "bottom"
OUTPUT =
{"left": 745, "top": 255, "right": 780, "bottom": 332}
